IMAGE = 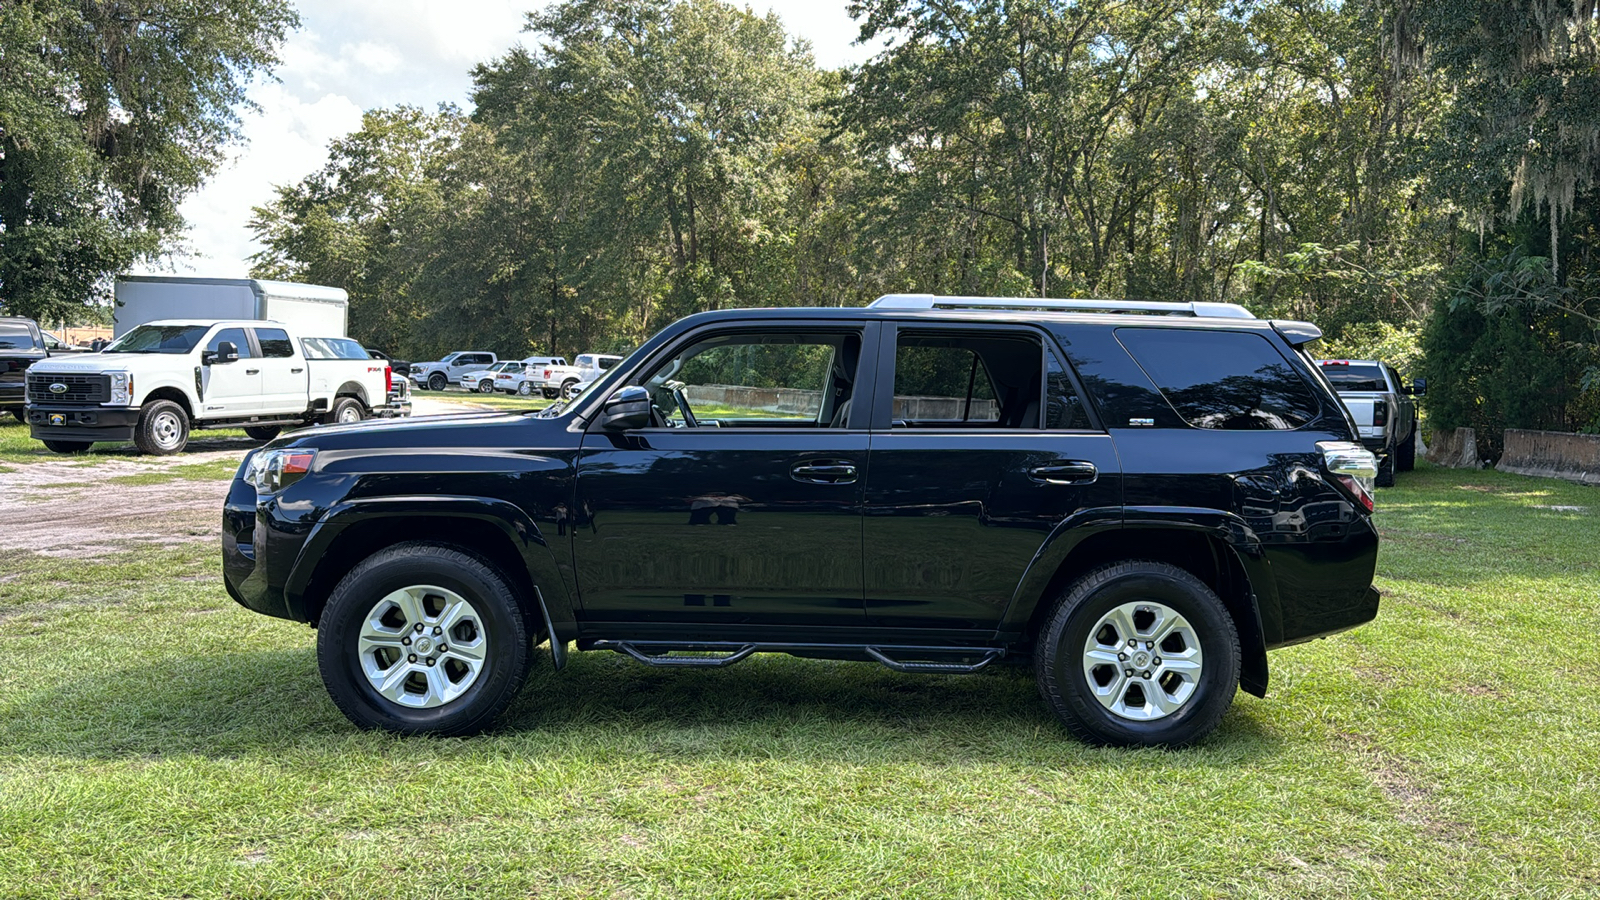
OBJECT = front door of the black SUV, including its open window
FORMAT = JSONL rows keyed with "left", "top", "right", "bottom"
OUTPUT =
{"left": 573, "top": 323, "right": 867, "bottom": 627}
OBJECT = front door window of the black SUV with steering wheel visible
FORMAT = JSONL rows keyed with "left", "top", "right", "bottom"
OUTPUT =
{"left": 643, "top": 331, "right": 861, "bottom": 428}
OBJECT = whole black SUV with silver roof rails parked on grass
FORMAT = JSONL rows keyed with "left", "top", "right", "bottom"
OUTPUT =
{"left": 222, "top": 295, "right": 1378, "bottom": 745}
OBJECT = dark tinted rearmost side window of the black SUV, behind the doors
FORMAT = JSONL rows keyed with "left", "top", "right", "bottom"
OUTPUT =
{"left": 1117, "top": 328, "right": 1320, "bottom": 431}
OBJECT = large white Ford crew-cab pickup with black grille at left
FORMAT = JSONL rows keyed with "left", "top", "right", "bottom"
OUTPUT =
{"left": 26, "top": 319, "right": 411, "bottom": 455}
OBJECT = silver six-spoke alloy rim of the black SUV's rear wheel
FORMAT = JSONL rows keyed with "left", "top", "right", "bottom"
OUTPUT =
{"left": 1083, "top": 601, "right": 1205, "bottom": 722}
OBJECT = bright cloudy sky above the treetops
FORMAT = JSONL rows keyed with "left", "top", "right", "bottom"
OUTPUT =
{"left": 141, "top": 0, "right": 870, "bottom": 277}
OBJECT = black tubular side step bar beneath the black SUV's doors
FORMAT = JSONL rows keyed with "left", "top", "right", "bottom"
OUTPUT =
{"left": 592, "top": 639, "right": 1005, "bottom": 674}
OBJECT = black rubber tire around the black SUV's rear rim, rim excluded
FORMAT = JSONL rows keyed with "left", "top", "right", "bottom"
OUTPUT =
{"left": 1034, "top": 560, "right": 1238, "bottom": 746}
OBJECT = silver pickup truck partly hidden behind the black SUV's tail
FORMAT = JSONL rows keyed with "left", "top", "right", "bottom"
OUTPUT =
{"left": 1317, "top": 359, "right": 1427, "bottom": 487}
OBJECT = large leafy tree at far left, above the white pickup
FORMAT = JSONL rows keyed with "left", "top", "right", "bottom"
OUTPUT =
{"left": 0, "top": 0, "right": 298, "bottom": 319}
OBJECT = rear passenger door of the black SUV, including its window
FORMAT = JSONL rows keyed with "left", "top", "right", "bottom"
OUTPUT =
{"left": 864, "top": 323, "right": 1122, "bottom": 634}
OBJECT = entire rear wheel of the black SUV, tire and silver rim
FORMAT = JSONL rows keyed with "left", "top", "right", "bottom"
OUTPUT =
{"left": 1034, "top": 560, "right": 1238, "bottom": 746}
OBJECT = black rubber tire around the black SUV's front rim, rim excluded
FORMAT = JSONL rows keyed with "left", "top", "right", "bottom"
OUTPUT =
{"left": 317, "top": 541, "right": 533, "bottom": 735}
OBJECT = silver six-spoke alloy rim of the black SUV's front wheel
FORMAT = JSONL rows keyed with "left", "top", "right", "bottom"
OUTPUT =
{"left": 357, "top": 585, "right": 488, "bottom": 709}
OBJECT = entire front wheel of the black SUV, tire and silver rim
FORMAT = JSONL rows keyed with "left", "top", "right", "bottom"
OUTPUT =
{"left": 317, "top": 541, "right": 533, "bottom": 735}
